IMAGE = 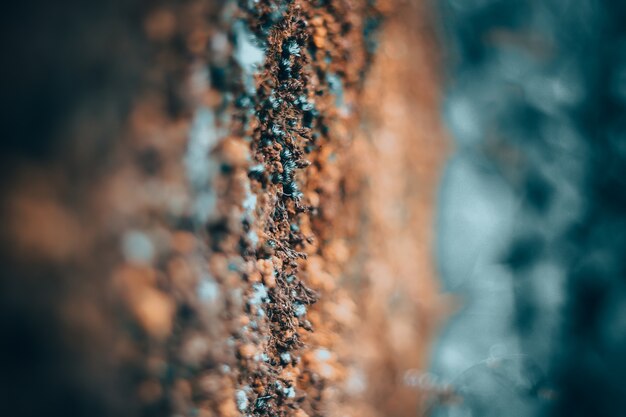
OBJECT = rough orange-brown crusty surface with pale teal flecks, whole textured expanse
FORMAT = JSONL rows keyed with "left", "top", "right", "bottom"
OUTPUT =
{"left": 0, "top": 0, "right": 446, "bottom": 417}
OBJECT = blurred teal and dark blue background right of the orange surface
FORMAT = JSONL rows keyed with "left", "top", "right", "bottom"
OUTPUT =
{"left": 433, "top": 0, "right": 626, "bottom": 417}
